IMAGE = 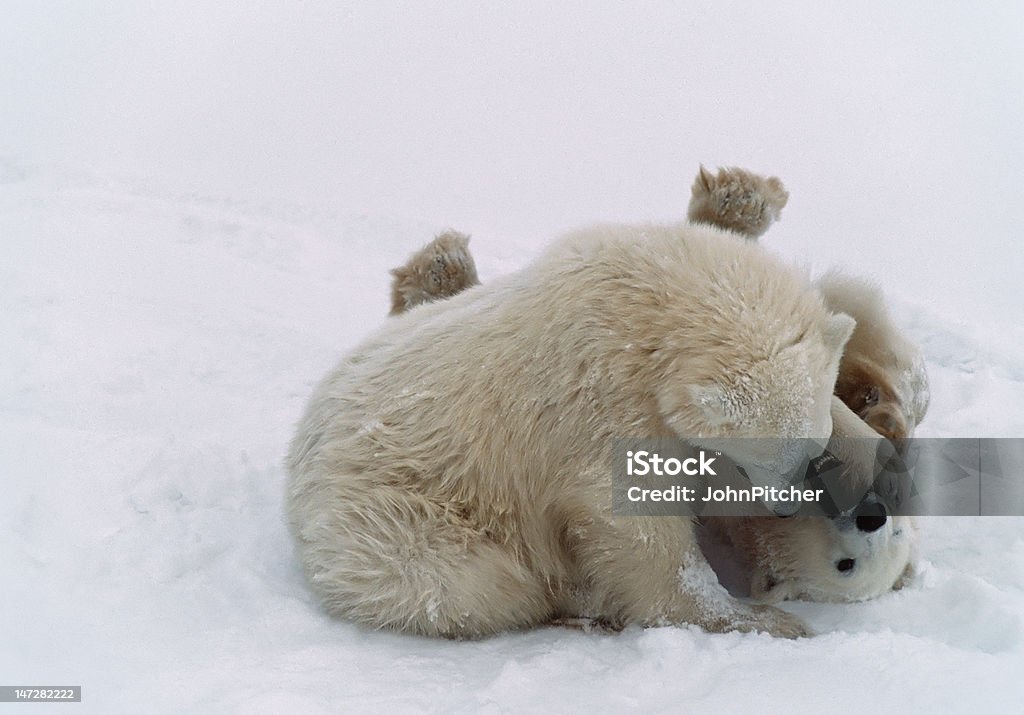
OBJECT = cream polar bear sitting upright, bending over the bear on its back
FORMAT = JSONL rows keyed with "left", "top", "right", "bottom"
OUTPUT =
{"left": 287, "top": 218, "right": 853, "bottom": 638}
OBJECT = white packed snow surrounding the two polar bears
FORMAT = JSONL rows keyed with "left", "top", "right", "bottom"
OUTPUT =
{"left": 0, "top": 2, "right": 1024, "bottom": 713}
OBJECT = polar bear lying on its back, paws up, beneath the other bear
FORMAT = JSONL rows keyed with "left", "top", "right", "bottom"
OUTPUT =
{"left": 376, "top": 167, "right": 928, "bottom": 606}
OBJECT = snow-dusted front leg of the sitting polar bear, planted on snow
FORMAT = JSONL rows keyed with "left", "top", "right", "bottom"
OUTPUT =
{"left": 573, "top": 516, "right": 810, "bottom": 638}
